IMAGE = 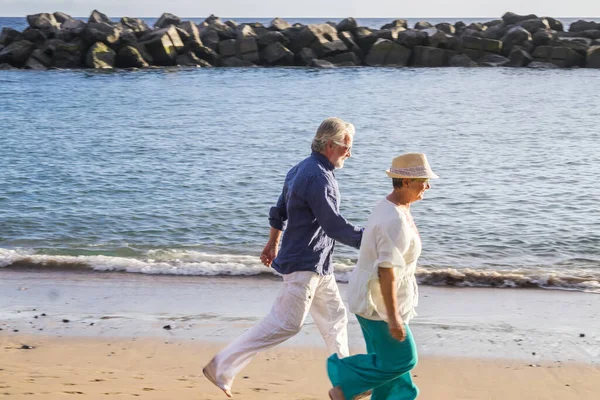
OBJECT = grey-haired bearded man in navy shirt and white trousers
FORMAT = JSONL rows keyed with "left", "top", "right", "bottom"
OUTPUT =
{"left": 203, "top": 118, "right": 362, "bottom": 397}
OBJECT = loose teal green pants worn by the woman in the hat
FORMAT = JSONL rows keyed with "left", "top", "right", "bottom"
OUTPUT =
{"left": 327, "top": 315, "right": 419, "bottom": 400}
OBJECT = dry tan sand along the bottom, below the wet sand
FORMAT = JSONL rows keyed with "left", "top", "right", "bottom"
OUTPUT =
{"left": 0, "top": 333, "right": 600, "bottom": 400}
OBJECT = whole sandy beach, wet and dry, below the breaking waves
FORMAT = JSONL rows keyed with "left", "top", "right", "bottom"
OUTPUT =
{"left": 0, "top": 269, "right": 600, "bottom": 400}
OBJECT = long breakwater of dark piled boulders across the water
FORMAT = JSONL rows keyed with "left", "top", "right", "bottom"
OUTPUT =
{"left": 0, "top": 10, "right": 600, "bottom": 70}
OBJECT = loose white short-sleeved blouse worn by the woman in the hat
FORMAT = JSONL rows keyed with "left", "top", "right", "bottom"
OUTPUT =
{"left": 348, "top": 199, "right": 421, "bottom": 323}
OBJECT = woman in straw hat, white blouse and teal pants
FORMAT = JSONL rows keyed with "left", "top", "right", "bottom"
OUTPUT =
{"left": 327, "top": 153, "right": 438, "bottom": 400}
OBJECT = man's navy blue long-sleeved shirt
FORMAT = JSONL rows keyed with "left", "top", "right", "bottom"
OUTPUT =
{"left": 269, "top": 151, "right": 363, "bottom": 275}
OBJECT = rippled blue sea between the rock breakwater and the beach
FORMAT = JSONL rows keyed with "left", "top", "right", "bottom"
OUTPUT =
{"left": 0, "top": 29, "right": 600, "bottom": 293}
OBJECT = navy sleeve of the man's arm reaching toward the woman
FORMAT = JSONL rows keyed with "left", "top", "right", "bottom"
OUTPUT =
{"left": 307, "top": 176, "right": 363, "bottom": 249}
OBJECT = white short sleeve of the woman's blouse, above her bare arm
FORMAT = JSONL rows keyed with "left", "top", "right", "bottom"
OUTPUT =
{"left": 375, "top": 221, "right": 409, "bottom": 268}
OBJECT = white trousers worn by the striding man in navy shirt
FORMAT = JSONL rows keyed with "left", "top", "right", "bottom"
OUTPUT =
{"left": 207, "top": 271, "right": 349, "bottom": 389}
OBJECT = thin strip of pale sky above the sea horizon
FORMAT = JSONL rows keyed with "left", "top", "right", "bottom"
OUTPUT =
{"left": 0, "top": 0, "right": 600, "bottom": 18}
